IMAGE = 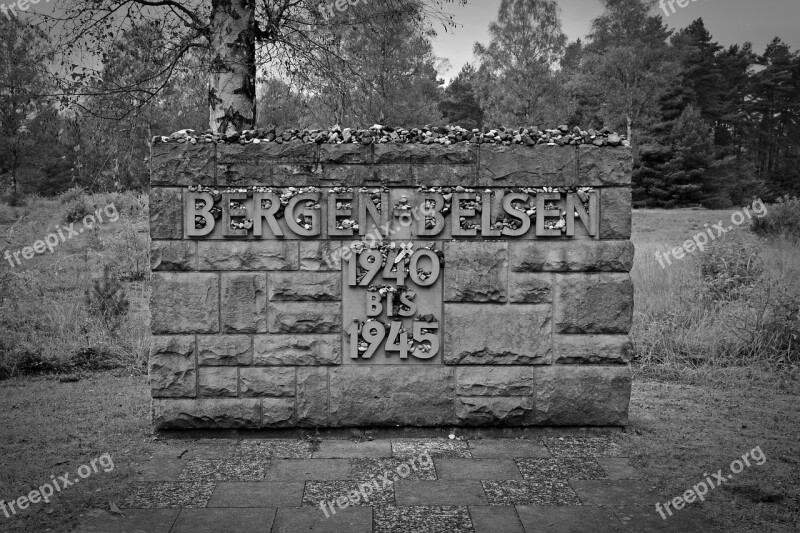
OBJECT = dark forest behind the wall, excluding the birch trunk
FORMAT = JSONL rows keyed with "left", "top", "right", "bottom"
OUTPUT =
{"left": 0, "top": 0, "right": 800, "bottom": 208}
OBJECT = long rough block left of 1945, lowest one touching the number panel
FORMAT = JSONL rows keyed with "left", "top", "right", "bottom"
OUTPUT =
{"left": 253, "top": 335, "right": 342, "bottom": 366}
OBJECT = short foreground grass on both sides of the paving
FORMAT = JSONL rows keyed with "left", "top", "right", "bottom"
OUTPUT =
{"left": 0, "top": 374, "right": 800, "bottom": 532}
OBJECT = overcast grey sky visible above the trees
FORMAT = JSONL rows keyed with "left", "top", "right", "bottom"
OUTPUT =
{"left": 434, "top": 0, "right": 800, "bottom": 81}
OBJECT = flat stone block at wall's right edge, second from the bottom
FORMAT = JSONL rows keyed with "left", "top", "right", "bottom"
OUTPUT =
{"left": 553, "top": 335, "right": 633, "bottom": 364}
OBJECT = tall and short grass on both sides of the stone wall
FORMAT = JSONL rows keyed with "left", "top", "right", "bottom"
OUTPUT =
{"left": 0, "top": 202, "right": 800, "bottom": 532}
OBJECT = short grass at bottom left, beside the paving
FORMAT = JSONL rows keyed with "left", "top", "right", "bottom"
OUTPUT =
{"left": 0, "top": 371, "right": 155, "bottom": 533}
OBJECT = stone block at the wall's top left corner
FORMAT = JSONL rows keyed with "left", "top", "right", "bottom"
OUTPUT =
{"left": 150, "top": 142, "right": 216, "bottom": 187}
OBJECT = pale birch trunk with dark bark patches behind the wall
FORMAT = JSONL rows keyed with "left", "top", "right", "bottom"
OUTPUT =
{"left": 208, "top": 0, "right": 256, "bottom": 134}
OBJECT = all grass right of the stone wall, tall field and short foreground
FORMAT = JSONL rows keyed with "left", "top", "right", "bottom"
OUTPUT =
{"left": 626, "top": 210, "right": 800, "bottom": 532}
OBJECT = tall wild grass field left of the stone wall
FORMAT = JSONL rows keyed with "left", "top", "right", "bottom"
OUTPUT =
{"left": 0, "top": 194, "right": 149, "bottom": 379}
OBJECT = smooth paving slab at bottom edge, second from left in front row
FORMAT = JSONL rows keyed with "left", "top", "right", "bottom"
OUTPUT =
{"left": 170, "top": 509, "right": 276, "bottom": 533}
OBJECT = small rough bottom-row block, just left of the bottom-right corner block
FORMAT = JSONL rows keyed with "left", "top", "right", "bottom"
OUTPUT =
{"left": 456, "top": 396, "right": 534, "bottom": 426}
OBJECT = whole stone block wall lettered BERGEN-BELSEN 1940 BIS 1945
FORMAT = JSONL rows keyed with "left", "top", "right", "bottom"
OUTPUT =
{"left": 150, "top": 128, "right": 634, "bottom": 428}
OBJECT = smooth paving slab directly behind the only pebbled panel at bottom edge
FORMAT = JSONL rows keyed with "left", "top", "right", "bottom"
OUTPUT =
{"left": 395, "top": 480, "right": 489, "bottom": 507}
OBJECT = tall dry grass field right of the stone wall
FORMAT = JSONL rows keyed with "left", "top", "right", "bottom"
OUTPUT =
{"left": 632, "top": 210, "right": 800, "bottom": 387}
